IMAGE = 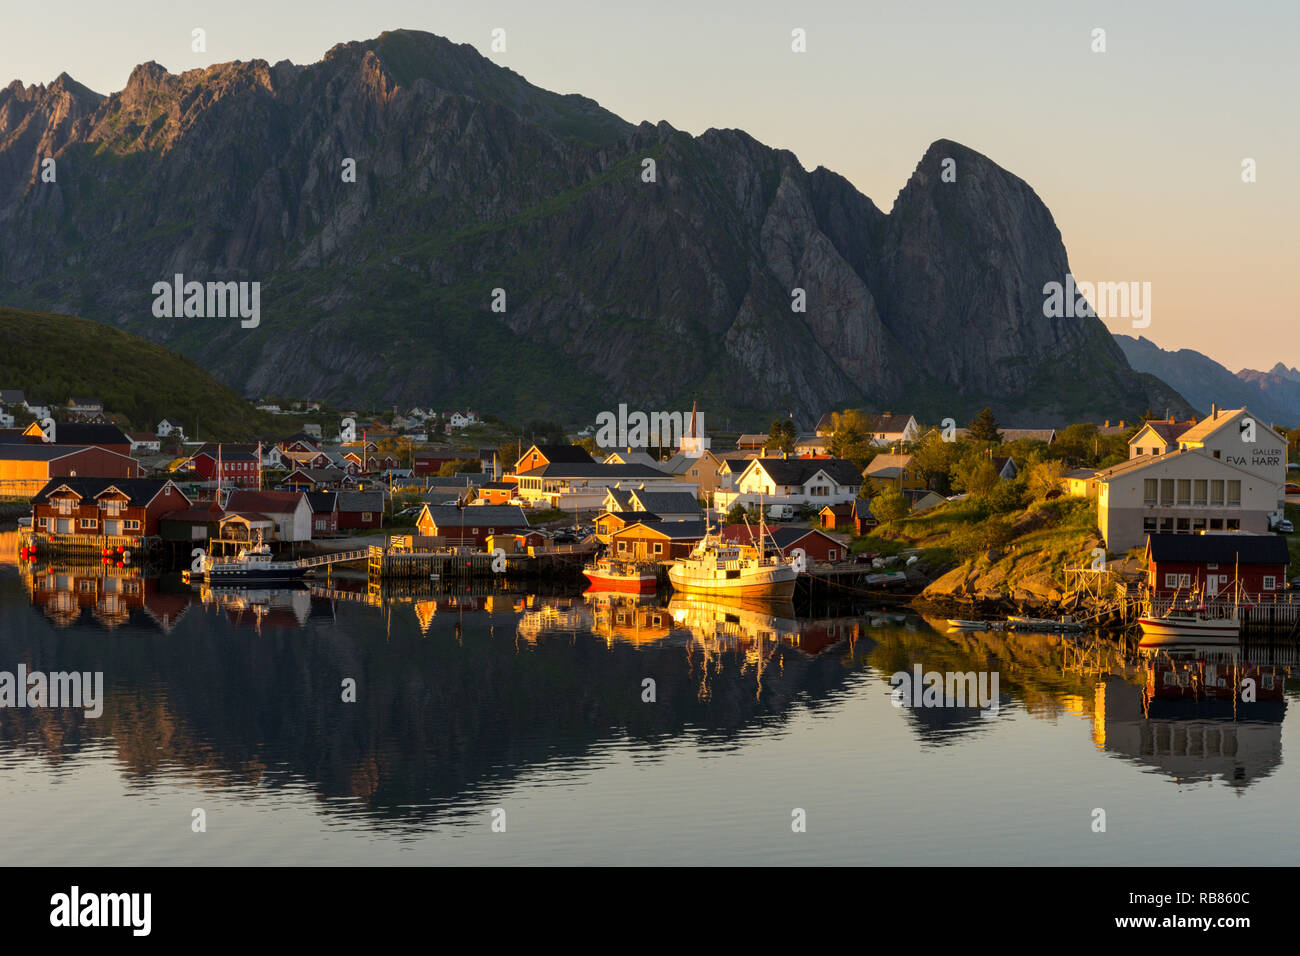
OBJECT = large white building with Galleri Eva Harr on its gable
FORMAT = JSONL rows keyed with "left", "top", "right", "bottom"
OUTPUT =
{"left": 1093, "top": 408, "right": 1287, "bottom": 551}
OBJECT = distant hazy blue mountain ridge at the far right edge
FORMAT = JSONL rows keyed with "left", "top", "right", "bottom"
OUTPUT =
{"left": 1115, "top": 334, "right": 1300, "bottom": 427}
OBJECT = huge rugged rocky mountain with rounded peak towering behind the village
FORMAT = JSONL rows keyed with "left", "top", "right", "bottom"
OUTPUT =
{"left": 0, "top": 30, "right": 1184, "bottom": 424}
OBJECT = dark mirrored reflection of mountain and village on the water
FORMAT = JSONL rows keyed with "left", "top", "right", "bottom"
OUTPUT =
{"left": 0, "top": 530, "right": 1294, "bottom": 829}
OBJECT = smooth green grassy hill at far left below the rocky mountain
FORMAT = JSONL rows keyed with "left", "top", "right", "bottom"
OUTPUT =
{"left": 0, "top": 307, "right": 299, "bottom": 441}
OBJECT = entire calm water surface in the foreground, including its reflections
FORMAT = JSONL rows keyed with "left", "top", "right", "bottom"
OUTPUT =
{"left": 0, "top": 535, "right": 1300, "bottom": 865}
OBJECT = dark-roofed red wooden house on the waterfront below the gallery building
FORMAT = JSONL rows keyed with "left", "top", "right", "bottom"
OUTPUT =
{"left": 1147, "top": 533, "right": 1290, "bottom": 601}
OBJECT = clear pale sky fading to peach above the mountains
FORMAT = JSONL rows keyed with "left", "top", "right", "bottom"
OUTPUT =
{"left": 0, "top": 0, "right": 1300, "bottom": 369}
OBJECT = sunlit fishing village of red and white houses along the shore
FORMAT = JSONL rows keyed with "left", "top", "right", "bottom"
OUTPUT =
{"left": 0, "top": 389, "right": 1300, "bottom": 655}
